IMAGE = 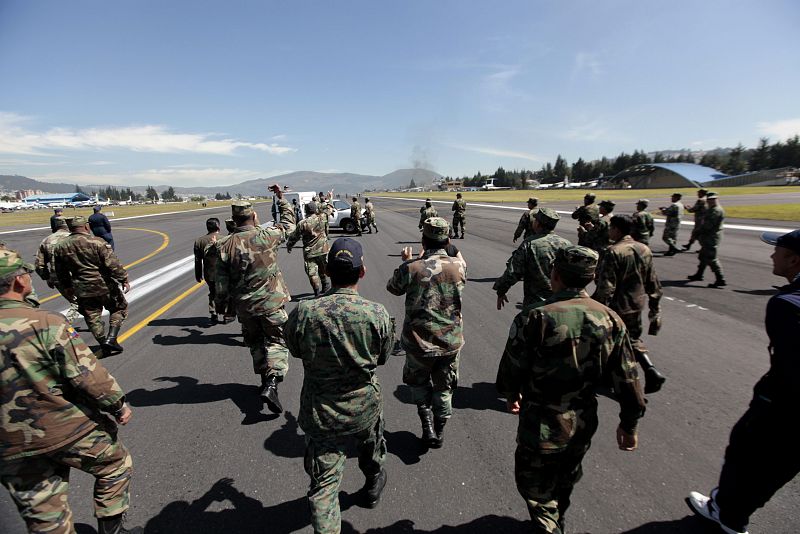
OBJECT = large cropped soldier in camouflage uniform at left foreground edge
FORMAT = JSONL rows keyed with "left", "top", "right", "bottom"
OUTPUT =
{"left": 0, "top": 250, "right": 141, "bottom": 534}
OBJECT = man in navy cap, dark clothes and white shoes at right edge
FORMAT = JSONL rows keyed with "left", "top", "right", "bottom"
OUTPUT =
{"left": 686, "top": 230, "right": 800, "bottom": 534}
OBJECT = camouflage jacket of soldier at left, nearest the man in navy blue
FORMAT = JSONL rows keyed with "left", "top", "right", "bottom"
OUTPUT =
{"left": 55, "top": 233, "right": 128, "bottom": 298}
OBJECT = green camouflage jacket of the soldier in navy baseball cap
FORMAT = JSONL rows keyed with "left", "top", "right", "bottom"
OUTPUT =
{"left": 284, "top": 288, "right": 394, "bottom": 436}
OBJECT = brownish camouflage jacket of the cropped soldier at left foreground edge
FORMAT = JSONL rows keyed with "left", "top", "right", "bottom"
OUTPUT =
{"left": 0, "top": 299, "right": 124, "bottom": 460}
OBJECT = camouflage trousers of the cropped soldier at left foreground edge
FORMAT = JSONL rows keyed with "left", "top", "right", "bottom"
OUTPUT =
{"left": 0, "top": 427, "right": 133, "bottom": 534}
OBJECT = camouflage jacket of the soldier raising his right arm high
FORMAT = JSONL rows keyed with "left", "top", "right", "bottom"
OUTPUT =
{"left": 214, "top": 199, "right": 295, "bottom": 318}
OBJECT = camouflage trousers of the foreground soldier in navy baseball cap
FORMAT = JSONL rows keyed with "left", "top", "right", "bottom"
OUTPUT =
{"left": 304, "top": 414, "right": 386, "bottom": 534}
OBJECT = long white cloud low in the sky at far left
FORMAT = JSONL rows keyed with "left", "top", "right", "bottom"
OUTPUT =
{"left": 0, "top": 113, "right": 297, "bottom": 156}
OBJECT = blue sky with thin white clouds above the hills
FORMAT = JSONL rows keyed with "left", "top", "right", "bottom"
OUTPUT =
{"left": 0, "top": 0, "right": 800, "bottom": 186}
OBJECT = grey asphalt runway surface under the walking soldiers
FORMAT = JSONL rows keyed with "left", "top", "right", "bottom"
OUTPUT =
{"left": 0, "top": 199, "right": 800, "bottom": 534}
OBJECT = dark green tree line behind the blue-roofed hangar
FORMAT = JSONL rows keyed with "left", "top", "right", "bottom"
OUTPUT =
{"left": 440, "top": 135, "right": 800, "bottom": 189}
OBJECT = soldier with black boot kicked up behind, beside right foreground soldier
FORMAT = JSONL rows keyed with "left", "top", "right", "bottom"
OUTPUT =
{"left": 592, "top": 215, "right": 667, "bottom": 393}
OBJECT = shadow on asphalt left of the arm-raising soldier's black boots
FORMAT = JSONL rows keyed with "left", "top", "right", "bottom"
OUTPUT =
{"left": 126, "top": 376, "right": 278, "bottom": 425}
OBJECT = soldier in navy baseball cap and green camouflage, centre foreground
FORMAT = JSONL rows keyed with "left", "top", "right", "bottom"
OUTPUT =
{"left": 286, "top": 237, "right": 394, "bottom": 534}
